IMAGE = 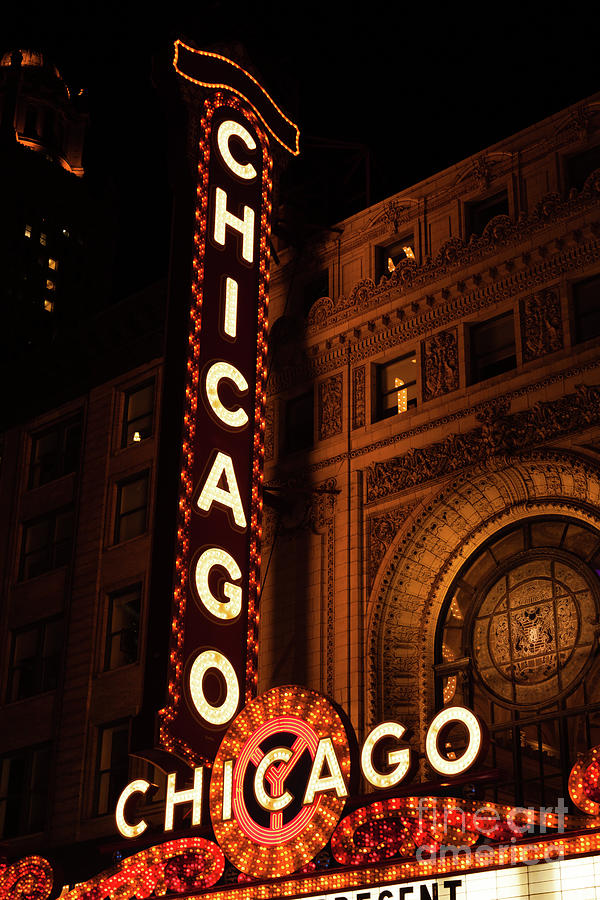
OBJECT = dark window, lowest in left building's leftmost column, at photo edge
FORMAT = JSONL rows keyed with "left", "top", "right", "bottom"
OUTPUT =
{"left": 0, "top": 746, "right": 51, "bottom": 840}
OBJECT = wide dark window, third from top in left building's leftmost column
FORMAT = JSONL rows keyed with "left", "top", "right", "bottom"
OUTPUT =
{"left": 8, "top": 619, "right": 64, "bottom": 703}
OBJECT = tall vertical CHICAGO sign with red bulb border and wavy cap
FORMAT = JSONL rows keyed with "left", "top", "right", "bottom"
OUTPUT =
{"left": 160, "top": 41, "right": 299, "bottom": 766}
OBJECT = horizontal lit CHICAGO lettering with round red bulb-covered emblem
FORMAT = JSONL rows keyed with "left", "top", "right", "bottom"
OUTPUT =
{"left": 116, "top": 685, "right": 555, "bottom": 878}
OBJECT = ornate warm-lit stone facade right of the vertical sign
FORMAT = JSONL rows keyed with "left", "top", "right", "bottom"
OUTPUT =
{"left": 268, "top": 96, "right": 600, "bottom": 796}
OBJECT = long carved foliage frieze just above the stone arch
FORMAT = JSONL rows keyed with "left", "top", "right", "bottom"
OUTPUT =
{"left": 367, "top": 384, "right": 600, "bottom": 502}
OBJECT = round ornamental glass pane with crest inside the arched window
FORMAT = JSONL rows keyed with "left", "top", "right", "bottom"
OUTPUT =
{"left": 472, "top": 553, "right": 597, "bottom": 705}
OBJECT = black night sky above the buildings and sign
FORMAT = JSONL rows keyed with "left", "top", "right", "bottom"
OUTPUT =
{"left": 3, "top": 0, "right": 600, "bottom": 296}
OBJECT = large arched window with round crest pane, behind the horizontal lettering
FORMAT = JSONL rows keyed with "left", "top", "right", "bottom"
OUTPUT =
{"left": 435, "top": 517, "right": 600, "bottom": 806}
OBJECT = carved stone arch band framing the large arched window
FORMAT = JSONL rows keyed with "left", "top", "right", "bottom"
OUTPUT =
{"left": 366, "top": 450, "right": 600, "bottom": 745}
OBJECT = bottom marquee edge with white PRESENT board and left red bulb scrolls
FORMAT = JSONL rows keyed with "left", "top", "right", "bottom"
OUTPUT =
{"left": 9, "top": 832, "right": 600, "bottom": 900}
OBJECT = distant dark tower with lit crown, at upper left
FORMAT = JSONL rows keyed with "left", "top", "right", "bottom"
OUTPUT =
{"left": 0, "top": 50, "right": 112, "bottom": 366}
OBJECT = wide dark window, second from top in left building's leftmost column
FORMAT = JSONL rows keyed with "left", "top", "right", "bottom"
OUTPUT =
{"left": 19, "top": 509, "right": 74, "bottom": 579}
